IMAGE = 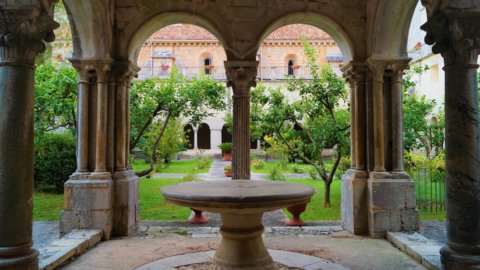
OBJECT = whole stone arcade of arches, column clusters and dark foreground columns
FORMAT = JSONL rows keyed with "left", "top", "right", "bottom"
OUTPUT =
{"left": 0, "top": 0, "right": 480, "bottom": 270}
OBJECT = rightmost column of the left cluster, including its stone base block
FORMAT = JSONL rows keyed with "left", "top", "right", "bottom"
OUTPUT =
{"left": 112, "top": 62, "right": 140, "bottom": 237}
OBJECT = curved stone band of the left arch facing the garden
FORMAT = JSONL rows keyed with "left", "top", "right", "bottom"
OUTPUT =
{"left": 125, "top": 12, "right": 225, "bottom": 63}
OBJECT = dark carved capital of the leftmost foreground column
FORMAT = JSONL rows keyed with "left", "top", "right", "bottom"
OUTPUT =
{"left": 0, "top": 4, "right": 59, "bottom": 67}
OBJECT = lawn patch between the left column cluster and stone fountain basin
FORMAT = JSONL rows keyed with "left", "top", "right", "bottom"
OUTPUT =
{"left": 139, "top": 178, "right": 191, "bottom": 220}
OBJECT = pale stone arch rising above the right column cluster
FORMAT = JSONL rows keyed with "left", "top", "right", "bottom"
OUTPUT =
{"left": 368, "top": 0, "right": 418, "bottom": 59}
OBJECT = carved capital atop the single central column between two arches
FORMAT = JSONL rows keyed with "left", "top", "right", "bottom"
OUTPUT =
{"left": 225, "top": 61, "right": 258, "bottom": 97}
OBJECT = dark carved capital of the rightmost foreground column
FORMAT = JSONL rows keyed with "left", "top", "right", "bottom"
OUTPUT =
{"left": 421, "top": 9, "right": 480, "bottom": 66}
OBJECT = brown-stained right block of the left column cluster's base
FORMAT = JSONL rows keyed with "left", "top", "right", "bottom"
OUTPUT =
{"left": 112, "top": 170, "right": 140, "bottom": 237}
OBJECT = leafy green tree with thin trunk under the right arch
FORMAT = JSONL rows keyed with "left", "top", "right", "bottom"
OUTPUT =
{"left": 262, "top": 41, "right": 350, "bottom": 207}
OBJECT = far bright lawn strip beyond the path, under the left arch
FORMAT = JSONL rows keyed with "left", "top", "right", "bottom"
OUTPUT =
{"left": 132, "top": 159, "right": 213, "bottom": 173}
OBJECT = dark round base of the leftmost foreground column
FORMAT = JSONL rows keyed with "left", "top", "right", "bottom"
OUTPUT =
{"left": 0, "top": 247, "right": 39, "bottom": 270}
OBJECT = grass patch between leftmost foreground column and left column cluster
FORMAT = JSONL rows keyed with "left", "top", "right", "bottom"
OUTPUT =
{"left": 33, "top": 191, "right": 63, "bottom": 221}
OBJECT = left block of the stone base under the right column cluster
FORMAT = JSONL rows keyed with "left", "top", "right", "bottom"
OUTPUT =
{"left": 341, "top": 169, "right": 368, "bottom": 235}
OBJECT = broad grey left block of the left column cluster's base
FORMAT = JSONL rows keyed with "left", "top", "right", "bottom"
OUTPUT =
{"left": 60, "top": 174, "right": 113, "bottom": 240}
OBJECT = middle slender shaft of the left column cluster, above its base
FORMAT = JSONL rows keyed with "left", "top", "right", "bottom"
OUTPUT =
{"left": 95, "top": 63, "right": 110, "bottom": 175}
